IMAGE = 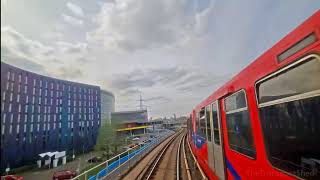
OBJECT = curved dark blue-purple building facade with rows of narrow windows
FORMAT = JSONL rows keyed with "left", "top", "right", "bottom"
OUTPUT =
{"left": 1, "top": 62, "right": 101, "bottom": 170}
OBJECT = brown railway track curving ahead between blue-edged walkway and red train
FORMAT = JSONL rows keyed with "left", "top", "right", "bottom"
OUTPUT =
{"left": 122, "top": 130, "right": 188, "bottom": 180}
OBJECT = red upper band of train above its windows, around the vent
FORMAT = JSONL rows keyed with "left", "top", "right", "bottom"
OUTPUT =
{"left": 195, "top": 10, "right": 320, "bottom": 110}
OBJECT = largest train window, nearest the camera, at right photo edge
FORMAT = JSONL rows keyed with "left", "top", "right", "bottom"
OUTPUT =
{"left": 256, "top": 57, "right": 320, "bottom": 180}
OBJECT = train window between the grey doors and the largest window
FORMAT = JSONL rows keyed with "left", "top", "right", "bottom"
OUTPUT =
{"left": 225, "top": 90, "right": 256, "bottom": 158}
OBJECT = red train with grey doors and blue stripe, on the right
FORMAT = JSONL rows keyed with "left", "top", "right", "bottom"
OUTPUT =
{"left": 188, "top": 10, "right": 320, "bottom": 180}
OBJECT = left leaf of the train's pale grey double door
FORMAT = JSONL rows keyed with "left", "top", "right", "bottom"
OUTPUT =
{"left": 205, "top": 105, "right": 215, "bottom": 171}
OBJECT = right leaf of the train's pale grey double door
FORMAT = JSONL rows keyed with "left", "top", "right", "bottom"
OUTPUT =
{"left": 211, "top": 101, "right": 225, "bottom": 179}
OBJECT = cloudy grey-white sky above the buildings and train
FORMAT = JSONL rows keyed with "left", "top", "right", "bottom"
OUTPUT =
{"left": 1, "top": 0, "right": 320, "bottom": 118}
